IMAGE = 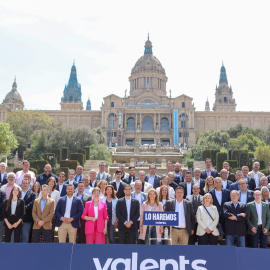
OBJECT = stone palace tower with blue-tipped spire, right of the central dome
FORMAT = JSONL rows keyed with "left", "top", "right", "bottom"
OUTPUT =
{"left": 213, "top": 63, "right": 236, "bottom": 112}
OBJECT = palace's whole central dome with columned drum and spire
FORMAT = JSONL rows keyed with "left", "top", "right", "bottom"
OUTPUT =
{"left": 129, "top": 34, "right": 168, "bottom": 97}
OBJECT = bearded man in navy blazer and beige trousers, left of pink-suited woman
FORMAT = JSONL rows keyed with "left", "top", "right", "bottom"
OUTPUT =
{"left": 55, "top": 184, "right": 83, "bottom": 244}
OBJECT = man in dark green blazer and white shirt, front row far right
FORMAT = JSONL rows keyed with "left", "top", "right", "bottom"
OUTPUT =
{"left": 247, "top": 190, "right": 270, "bottom": 248}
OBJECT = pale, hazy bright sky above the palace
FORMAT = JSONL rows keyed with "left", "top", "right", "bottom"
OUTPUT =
{"left": 0, "top": 0, "right": 270, "bottom": 111}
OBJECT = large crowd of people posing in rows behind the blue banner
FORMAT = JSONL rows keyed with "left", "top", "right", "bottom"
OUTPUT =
{"left": 0, "top": 158, "right": 270, "bottom": 248}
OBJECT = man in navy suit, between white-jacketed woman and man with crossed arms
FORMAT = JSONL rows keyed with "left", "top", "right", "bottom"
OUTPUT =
{"left": 209, "top": 177, "right": 230, "bottom": 229}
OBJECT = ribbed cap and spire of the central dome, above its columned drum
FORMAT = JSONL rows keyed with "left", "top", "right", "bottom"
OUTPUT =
{"left": 131, "top": 36, "right": 165, "bottom": 75}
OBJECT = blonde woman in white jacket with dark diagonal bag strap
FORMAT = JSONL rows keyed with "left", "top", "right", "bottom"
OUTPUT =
{"left": 196, "top": 193, "right": 219, "bottom": 245}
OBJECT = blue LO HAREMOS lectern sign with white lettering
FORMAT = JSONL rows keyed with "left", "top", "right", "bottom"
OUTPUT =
{"left": 143, "top": 211, "right": 179, "bottom": 226}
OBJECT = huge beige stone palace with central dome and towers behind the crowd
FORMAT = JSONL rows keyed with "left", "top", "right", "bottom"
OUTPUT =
{"left": 0, "top": 36, "right": 270, "bottom": 146}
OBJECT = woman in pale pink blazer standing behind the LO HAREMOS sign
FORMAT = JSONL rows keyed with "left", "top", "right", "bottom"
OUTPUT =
{"left": 139, "top": 188, "right": 163, "bottom": 245}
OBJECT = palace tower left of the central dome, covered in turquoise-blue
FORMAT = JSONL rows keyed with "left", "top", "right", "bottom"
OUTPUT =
{"left": 61, "top": 63, "right": 83, "bottom": 111}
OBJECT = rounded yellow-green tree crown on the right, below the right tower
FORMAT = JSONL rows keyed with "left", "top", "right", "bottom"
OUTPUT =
{"left": 230, "top": 133, "right": 265, "bottom": 152}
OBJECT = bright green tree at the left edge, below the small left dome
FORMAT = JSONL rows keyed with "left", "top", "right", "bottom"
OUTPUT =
{"left": 0, "top": 122, "right": 18, "bottom": 155}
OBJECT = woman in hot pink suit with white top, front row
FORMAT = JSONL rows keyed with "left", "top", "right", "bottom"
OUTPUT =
{"left": 82, "top": 187, "right": 109, "bottom": 244}
